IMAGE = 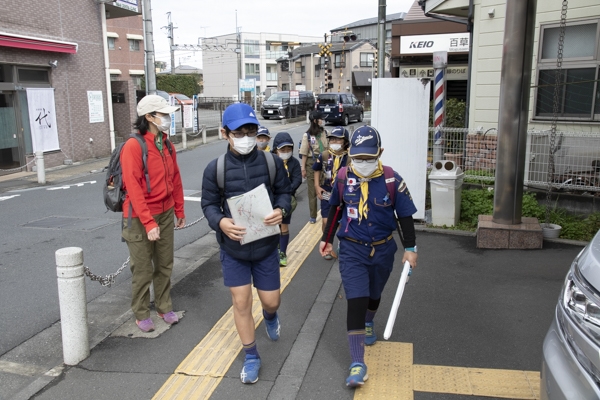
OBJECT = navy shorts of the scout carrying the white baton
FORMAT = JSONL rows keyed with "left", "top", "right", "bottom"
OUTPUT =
{"left": 338, "top": 239, "right": 398, "bottom": 299}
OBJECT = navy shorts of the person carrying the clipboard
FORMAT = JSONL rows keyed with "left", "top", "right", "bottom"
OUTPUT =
{"left": 220, "top": 249, "right": 281, "bottom": 291}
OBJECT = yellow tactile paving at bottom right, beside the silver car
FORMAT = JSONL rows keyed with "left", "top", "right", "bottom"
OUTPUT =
{"left": 354, "top": 341, "right": 540, "bottom": 400}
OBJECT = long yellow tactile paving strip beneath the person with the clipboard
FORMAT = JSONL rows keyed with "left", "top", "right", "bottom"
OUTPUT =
{"left": 153, "top": 217, "right": 321, "bottom": 400}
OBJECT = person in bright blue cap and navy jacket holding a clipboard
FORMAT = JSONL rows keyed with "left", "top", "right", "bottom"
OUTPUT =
{"left": 201, "top": 103, "right": 291, "bottom": 383}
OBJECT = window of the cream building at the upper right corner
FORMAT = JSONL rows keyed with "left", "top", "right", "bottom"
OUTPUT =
{"left": 534, "top": 19, "right": 600, "bottom": 121}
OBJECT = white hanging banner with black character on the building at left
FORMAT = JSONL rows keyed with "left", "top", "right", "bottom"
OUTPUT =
{"left": 27, "top": 88, "right": 60, "bottom": 153}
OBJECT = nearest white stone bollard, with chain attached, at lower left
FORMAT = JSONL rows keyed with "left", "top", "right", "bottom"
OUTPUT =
{"left": 55, "top": 247, "right": 90, "bottom": 365}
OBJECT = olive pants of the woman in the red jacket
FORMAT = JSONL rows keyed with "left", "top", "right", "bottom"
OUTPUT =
{"left": 123, "top": 208, "right": 175, "bottom": 321}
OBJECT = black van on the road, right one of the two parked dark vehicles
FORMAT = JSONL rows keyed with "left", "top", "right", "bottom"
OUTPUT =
{"left": 317, "top": 93, "right": 364, "bottom": 125}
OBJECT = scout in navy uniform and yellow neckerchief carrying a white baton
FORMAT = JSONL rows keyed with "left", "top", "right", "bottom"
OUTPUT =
{"left": 319, "top": 125, "right": 417, "bottom": 387}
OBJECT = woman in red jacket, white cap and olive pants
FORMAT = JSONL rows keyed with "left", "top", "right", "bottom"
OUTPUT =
{"left": 121, "top": 95, "right": 185, "bottom": 332}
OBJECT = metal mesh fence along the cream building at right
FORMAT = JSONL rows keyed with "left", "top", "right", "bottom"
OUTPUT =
{"left": 428, "top": 128, "right": 600, "bottom": 192}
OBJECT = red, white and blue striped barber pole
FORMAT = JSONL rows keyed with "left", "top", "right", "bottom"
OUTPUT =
{"left": 433, "top": 51, "right": 448, "bottom": 162}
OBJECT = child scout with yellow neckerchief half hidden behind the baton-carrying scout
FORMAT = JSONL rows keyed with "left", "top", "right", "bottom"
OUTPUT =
{"left": 313, "top": 126, "right": 350, "bottom": 260}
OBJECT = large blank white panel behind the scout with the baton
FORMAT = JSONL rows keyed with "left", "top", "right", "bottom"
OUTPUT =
{"left": 371, "top": 79, "right": 430, "bottom": 219}
